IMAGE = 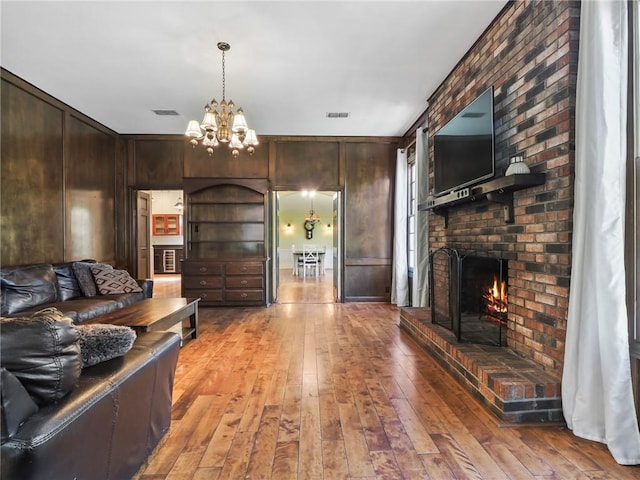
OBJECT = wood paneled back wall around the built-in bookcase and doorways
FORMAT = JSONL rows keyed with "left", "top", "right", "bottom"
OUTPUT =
{"left": 126, "top": 136, "right": 399, "bottom": 302}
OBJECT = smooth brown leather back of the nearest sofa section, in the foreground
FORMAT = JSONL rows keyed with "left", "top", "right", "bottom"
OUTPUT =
{"left": 0, "top": 332, "right": 180, "bottom": 480}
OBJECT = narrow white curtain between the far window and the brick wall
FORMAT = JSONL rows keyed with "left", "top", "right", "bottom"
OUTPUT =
{"left": 412, "top": 127, "right": 429, "bottom": 307}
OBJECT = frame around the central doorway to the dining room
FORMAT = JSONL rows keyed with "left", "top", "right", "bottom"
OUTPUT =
{"left": 268, "top": 187, "right": 344, "bottom": 303}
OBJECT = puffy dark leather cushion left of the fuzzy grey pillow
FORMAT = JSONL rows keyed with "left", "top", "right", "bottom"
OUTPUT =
{"left": 0, "top": 311, "right": 82, "bottom": 406}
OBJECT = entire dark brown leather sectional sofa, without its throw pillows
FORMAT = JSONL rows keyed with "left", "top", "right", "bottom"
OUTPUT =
{"left": 0, "top": 261, "right": 181, "bottom": 480}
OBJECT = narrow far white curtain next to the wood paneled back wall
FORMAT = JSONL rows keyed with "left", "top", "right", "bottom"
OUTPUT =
{"left": 391, "top": 149, "right": 409, "bottom": 306}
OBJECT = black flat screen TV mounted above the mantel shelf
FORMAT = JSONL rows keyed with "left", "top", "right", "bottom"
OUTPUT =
{"left": 433, "top": 87, "right": 494, "bottom": 196}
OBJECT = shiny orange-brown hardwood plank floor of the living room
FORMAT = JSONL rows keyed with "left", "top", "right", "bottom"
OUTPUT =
{"left": 135, "top": 276, "right": 640, "bottom": 480}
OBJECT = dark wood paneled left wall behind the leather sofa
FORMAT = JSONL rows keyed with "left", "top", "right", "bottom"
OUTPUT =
{"left": 0, "top": 70, "right": 119, "bottom": 265}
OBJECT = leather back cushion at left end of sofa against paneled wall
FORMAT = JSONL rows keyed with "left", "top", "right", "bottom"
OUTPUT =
{"left": 0, "top": 263, "right": 58, "bottom": 315}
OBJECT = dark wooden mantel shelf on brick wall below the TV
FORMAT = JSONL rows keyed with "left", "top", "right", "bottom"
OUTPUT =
{"left": 418, "top": 173, "right": 546, "bottom": 226}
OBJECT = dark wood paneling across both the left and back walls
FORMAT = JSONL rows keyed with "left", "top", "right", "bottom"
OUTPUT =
{"left": 1, "top": 70, "right": 399, "bottom": 301}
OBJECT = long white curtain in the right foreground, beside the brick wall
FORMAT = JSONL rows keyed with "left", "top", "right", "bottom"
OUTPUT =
{"left": 562, "top": 1, "right": 640, "bottom": 465}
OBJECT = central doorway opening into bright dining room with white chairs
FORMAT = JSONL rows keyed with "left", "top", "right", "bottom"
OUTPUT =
{"left": 271, "top": 190, "right": 342, "bottom": 303}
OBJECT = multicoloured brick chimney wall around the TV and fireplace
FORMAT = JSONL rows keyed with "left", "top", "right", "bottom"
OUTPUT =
{"left": 427, "top": 0, "right": 580, "bottom": 374}
